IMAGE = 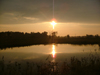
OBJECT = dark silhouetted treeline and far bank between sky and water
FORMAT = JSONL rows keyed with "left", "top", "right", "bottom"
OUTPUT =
{"left": 0, "top": 31, "right": 100, "bottom": 49}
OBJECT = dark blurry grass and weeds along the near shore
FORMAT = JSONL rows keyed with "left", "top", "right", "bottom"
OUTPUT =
{"left": 0, "top": 54, "right": 100, "bottom": 75}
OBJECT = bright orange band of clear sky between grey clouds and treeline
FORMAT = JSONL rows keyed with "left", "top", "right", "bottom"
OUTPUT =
{"left": 0, "top": 22, "right": 100, "bottom": 36}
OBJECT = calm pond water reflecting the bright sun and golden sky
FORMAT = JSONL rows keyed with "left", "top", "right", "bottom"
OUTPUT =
{"left": 0, "top": 44, "right": 100, "bottom": 62}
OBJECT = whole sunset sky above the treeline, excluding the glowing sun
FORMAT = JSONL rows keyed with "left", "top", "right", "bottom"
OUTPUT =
{"left": 0, "top": 0, "right": 100, "bottom": 36}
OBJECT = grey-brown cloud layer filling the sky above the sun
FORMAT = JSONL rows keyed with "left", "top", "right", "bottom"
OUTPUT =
{"left": 0, "top": 0, "right": 100, "bottom": 24}
